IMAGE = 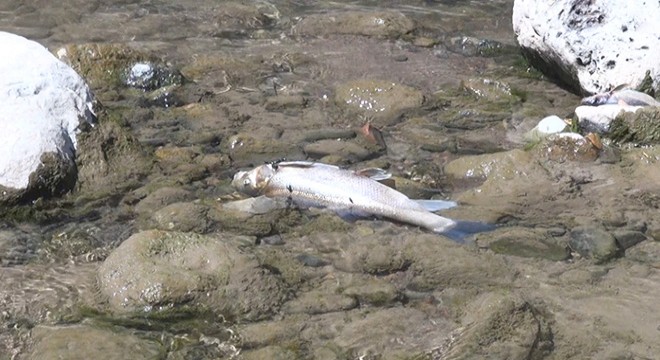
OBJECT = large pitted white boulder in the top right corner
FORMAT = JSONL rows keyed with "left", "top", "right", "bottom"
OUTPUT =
{"left": 513, "top": 0, "right": 660, "bottom": 94}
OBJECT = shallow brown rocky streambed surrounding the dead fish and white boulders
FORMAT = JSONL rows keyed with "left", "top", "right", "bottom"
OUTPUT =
{"left": 0, "top": 1, "right": 660, "bottom": 360}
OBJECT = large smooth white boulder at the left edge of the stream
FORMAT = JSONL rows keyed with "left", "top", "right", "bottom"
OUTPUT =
{"left": 0, "top": 32, "right": 95, "bottom": 190}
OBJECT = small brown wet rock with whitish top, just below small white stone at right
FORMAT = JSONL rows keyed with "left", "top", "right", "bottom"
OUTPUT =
{"left": 534, "top": 133, "right": 599, "bottom": 163}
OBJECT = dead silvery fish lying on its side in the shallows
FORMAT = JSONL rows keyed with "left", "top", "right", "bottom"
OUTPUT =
{"left": 232, "top": 161, "right": 494, "bottom": 242}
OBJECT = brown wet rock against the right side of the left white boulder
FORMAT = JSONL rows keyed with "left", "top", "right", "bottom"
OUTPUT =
{"left": 76, "top": 113, "right": 153, "bottom": 198}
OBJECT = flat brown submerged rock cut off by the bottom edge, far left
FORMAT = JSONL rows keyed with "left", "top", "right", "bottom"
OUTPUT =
{"left": 29, "top": 325, "right": 165, "bottom": 360}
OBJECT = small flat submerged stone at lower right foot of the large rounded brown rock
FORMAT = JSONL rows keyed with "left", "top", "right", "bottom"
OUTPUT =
{"left": 282, "top": 290, "right": 358, "bottom": 315}
